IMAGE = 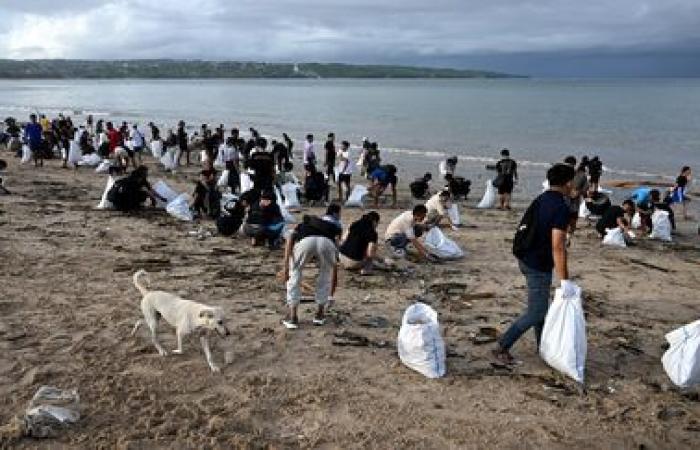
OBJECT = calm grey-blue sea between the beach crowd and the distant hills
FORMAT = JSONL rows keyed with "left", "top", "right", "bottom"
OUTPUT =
{"left": 0, "top": 79, "right": 700, "bottom": 178}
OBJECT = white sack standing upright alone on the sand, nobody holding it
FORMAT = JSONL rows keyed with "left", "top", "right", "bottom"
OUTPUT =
{"left": 397, "top": 302, "right": 445, "bottom": 378}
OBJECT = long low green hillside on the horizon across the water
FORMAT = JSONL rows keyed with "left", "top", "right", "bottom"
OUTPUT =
{"left": 0, "top": 59, "right": 515, "bottom": 79}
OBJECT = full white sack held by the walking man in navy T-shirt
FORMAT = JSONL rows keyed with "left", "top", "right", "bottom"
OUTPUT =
{"left": 540, "top": 286, "right": 586, "bottom": 383}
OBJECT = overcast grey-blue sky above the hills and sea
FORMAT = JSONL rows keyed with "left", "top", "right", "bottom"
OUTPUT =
{"left": 0, "top": 0, "right": 700, "bottom": 76}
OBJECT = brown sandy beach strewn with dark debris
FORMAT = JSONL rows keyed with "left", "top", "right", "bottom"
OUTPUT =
{"left": 0, "top": 152, "right": 700, "bottom": 449}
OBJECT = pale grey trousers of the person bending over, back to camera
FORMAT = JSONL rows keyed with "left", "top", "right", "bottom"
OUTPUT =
{"left": 287, "top": 236, "right": 338, "bottom": 306}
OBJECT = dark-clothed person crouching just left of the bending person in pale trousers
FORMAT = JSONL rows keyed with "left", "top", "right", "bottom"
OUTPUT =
{"left": 243, "top": 191, "right": 284, "bottom": 249}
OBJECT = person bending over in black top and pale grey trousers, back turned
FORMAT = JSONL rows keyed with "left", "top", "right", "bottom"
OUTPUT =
{"left": 282, "top": 209, "right": 342, "bottom": 329}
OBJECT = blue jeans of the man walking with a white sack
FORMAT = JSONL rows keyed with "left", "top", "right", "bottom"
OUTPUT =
{"left": 499, "top": 261, "right": 552, "bottom": 350}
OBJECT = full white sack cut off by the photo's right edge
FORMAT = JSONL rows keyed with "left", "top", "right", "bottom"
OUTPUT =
{"left": 661, "top": 320, "right": 700, "bottom": 388}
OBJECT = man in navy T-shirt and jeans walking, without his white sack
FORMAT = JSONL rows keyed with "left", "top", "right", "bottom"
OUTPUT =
{"left": 493, "top": 164, "right": 576, "bottom": 364}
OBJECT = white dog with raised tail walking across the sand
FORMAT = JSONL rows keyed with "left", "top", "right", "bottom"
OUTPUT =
{"left": 131, "top": 269, "right": 231, "bottom": 372}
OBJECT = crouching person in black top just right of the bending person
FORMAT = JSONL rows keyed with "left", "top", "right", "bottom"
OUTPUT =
{"left": 340, "top": 211, "right": 379, "bottom": 275}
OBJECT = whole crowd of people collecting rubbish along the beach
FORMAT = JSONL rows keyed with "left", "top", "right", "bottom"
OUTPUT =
{"left": 0, "top": 114, "right": 692, "bottom": 376}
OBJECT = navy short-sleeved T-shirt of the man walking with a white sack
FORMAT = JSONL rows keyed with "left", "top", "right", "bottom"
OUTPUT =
{"left": 521, "top": 191, "right": 570, "bottom": 272}
